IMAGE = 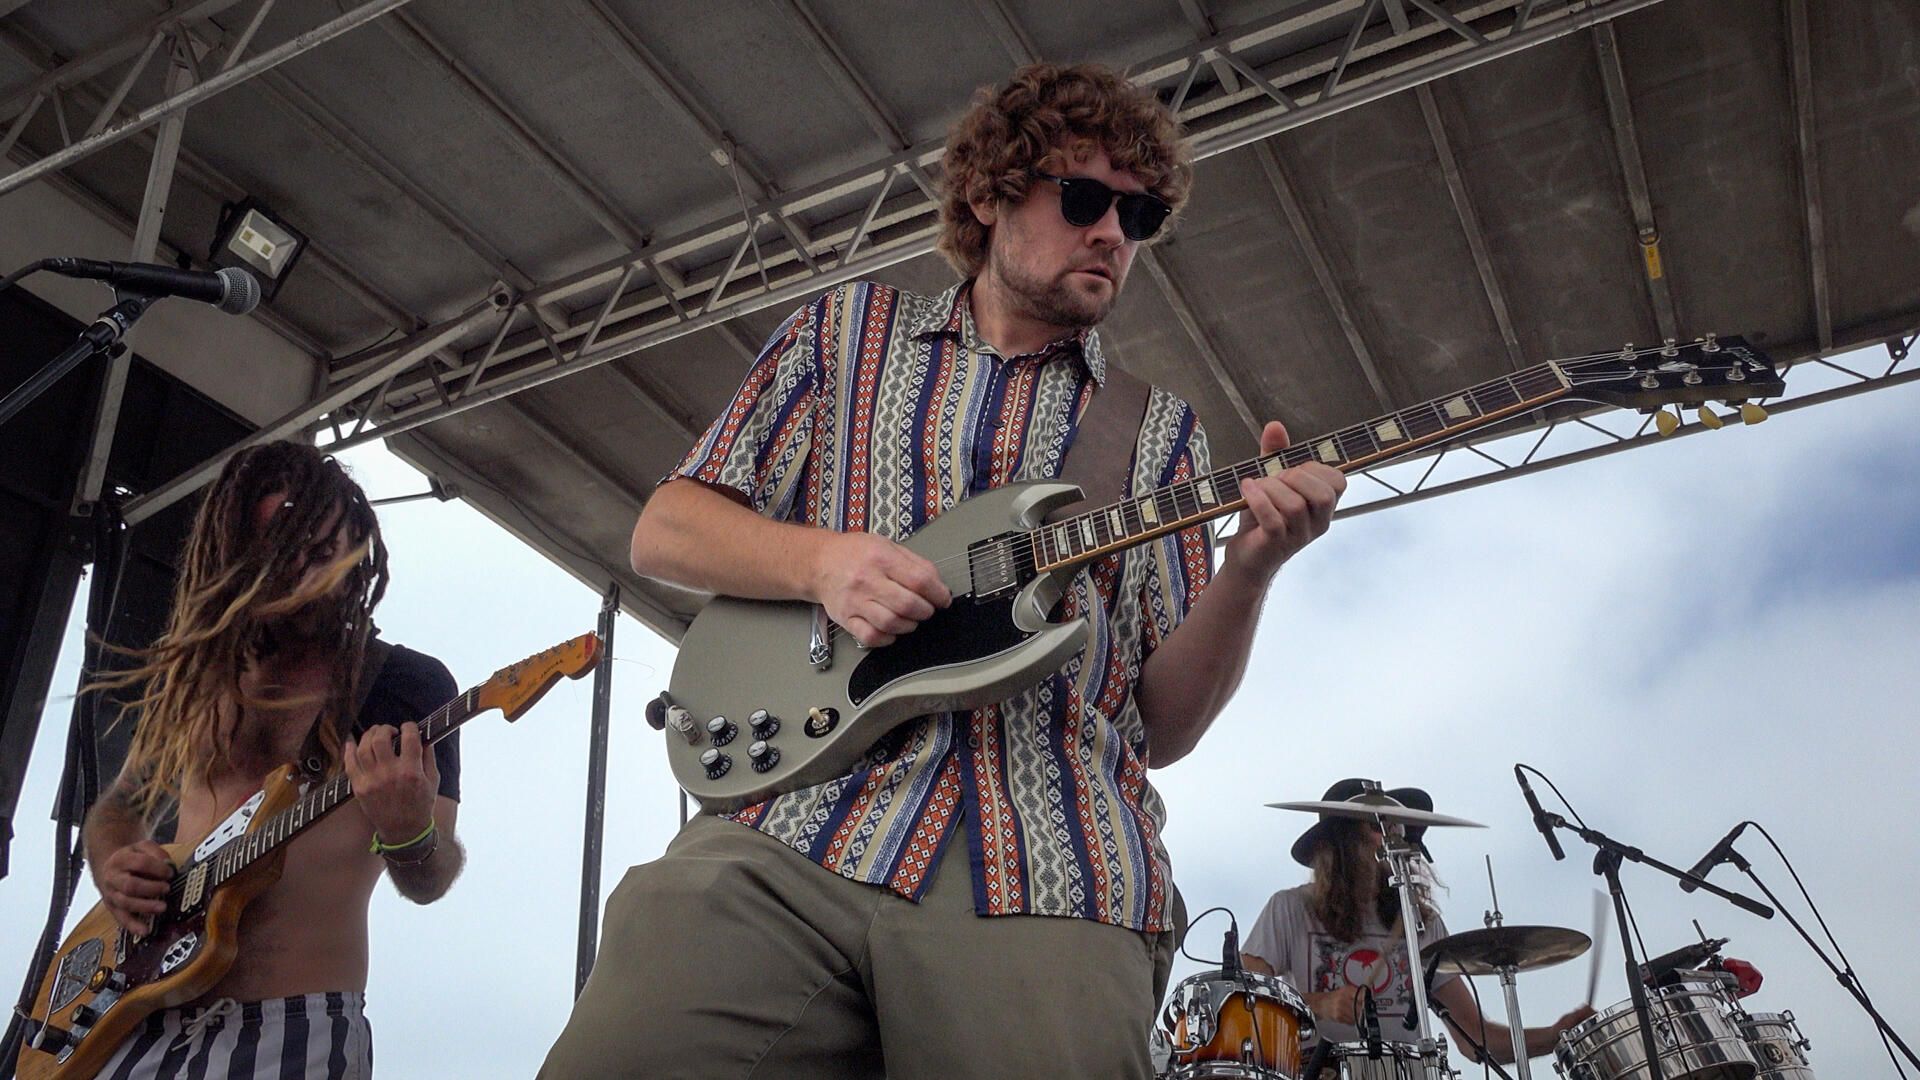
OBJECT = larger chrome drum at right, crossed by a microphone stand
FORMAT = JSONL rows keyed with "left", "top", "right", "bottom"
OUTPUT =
{"left": 1553, "top": 982, "right": 1759, "bottom": 1080}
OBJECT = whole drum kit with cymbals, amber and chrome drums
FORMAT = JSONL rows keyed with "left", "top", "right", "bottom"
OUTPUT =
{"left": 1152, "top": 782, "right": 1814, "bottom": 1080}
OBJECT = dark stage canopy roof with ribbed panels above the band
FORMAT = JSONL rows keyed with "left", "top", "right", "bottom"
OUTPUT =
{"left": 0, "top": 0, "right": 1920, "bottom": 638}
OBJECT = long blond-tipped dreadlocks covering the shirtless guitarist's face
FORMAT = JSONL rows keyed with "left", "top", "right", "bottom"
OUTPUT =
{"left": 88, "top": 434, "right": 388, "bottom": 813}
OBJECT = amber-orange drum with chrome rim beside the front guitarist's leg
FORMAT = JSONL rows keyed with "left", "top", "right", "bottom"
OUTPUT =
{"left": 1160, "top": 970, "right": 1313, "bottom": 1080}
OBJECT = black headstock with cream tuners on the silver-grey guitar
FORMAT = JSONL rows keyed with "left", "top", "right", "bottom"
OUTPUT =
{"left": 1553, "top": 334, "right": 1786, "bottom": 422}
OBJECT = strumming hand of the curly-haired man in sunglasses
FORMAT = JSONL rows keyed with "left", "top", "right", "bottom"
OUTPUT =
{"left": 810, "top": 532, "right": 952, "bottom": 648}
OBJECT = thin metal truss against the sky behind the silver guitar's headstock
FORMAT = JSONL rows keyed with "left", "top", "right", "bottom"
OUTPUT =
{"left": 1334, "top": 329, "right": 1920, "bottom": 517}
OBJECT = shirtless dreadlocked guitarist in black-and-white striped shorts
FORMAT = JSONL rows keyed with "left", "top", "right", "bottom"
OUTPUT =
{"left": 84, "top": 442, "right": 463, "bottom": 1078}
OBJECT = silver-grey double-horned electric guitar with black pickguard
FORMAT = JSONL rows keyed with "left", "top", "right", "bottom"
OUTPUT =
{"left": 647, "top": 336, "right": 1786, "bottom": 811}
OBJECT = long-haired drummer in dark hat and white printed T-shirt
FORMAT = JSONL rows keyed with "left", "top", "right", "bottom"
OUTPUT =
{"left": 1240, "top": 780, "right": 1594, "bottom": 1065}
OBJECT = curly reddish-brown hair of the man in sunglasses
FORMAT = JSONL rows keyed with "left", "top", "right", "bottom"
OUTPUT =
{"left": 939, "top": 63, "right": 1192, "bottom": 277}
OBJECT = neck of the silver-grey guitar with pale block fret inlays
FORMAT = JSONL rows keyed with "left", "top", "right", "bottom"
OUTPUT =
{"left": 1033, "top": 361, "right": 1571, "bottom": 571}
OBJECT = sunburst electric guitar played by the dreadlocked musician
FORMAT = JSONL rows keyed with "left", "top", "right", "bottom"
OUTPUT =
{"left": 17, "top": 634, "right": 601, "bottom": 1080}
